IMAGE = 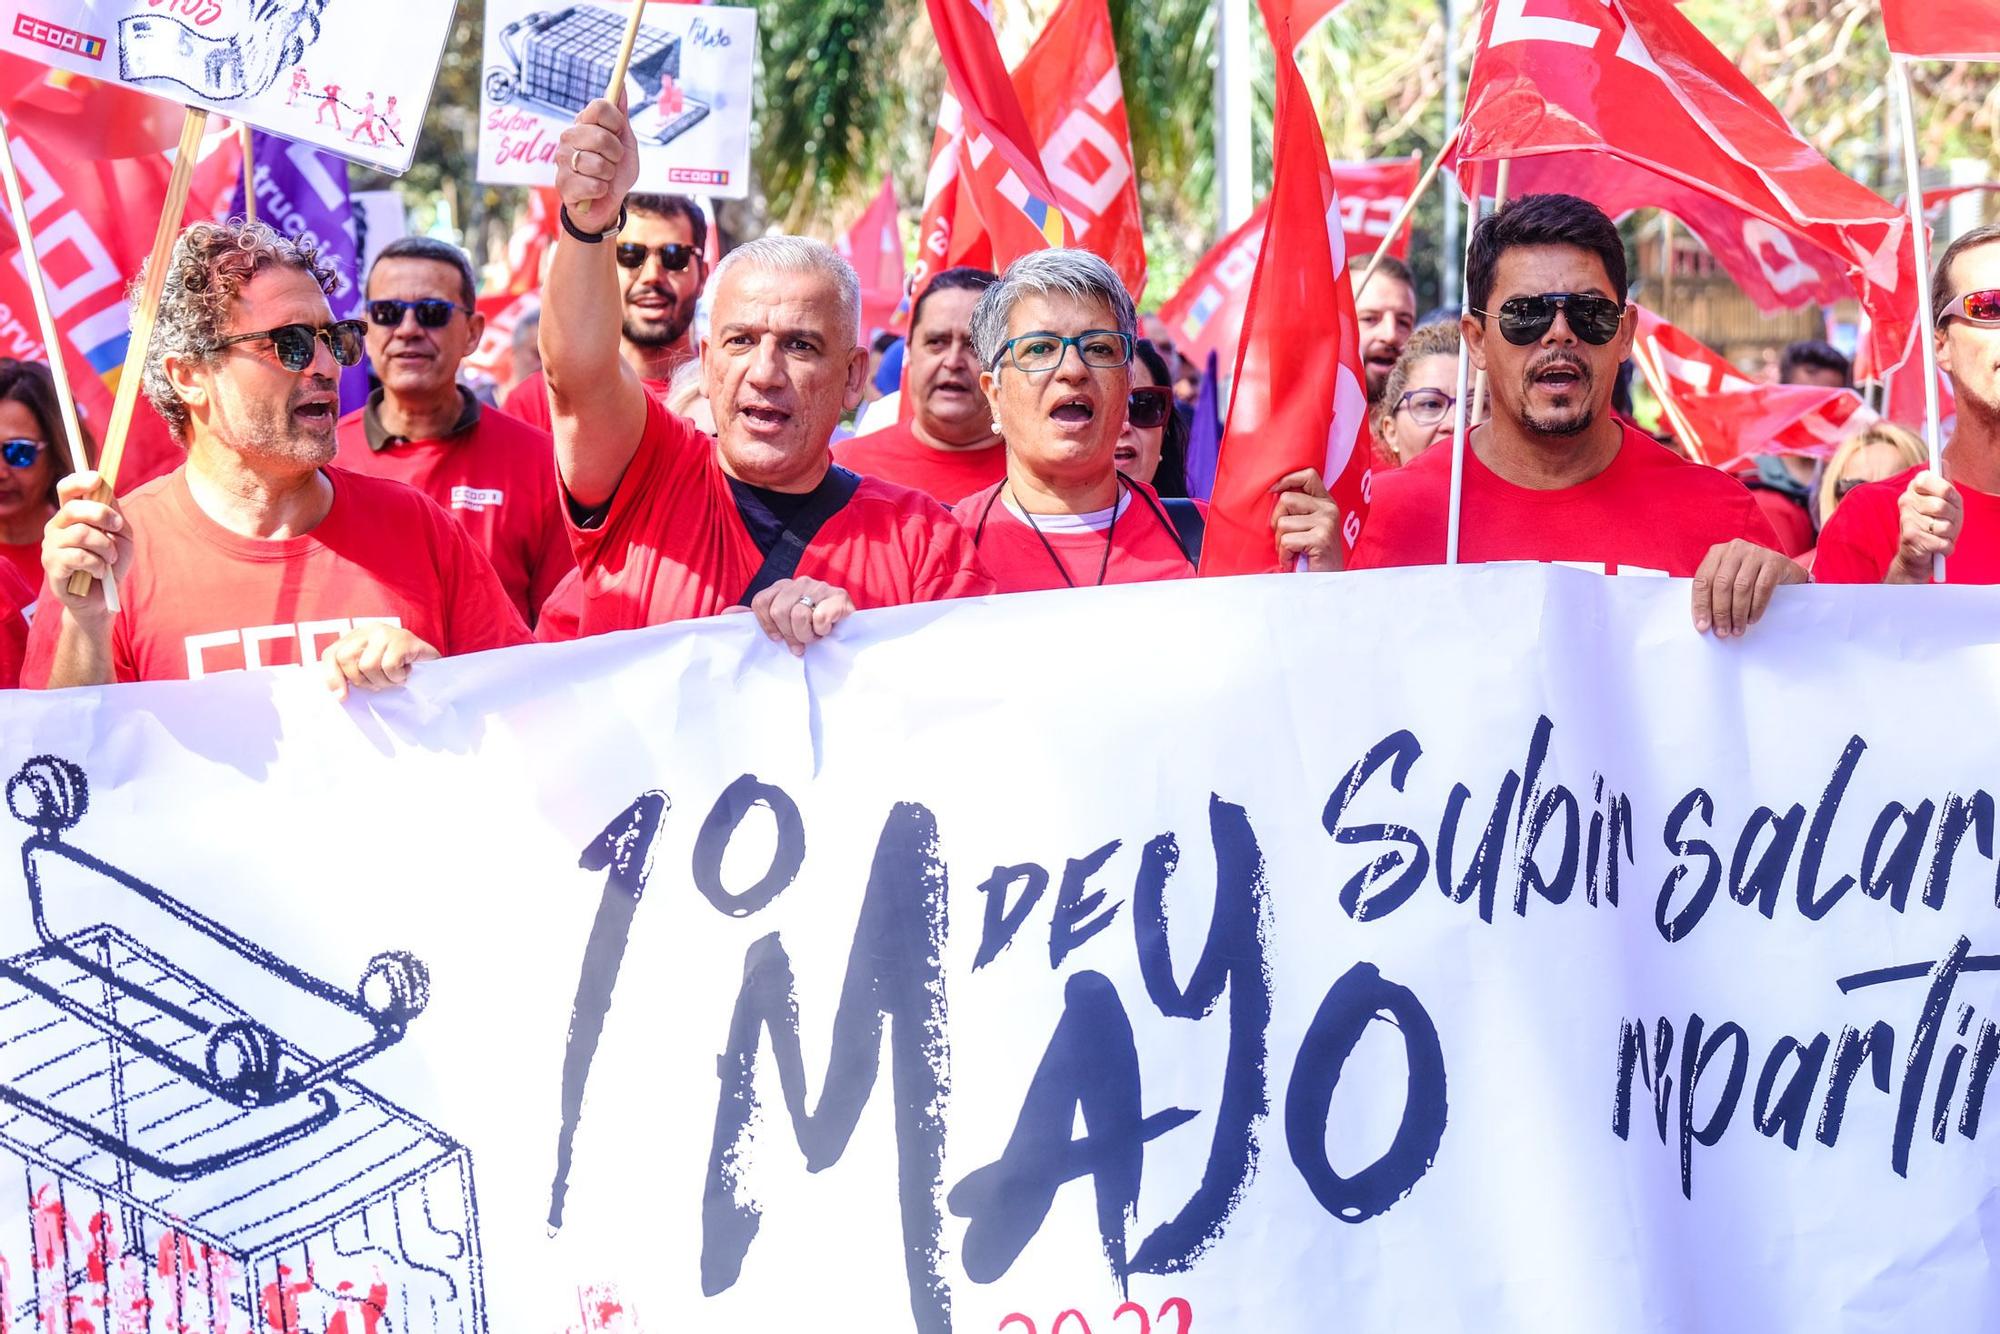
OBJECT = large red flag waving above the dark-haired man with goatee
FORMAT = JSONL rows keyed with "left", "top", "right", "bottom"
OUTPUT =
{"left": 1458, "top": 0, "right": 1912, "bottom": 376}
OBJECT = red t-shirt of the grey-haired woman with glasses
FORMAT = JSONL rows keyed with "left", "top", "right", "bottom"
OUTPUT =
{"left": 952, "top": 478, "right": 1194, "bottom": 592}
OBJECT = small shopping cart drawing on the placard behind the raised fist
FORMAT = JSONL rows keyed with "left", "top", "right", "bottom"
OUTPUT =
{"left": 486, "top": 4, "right": 712, "bottom": 146}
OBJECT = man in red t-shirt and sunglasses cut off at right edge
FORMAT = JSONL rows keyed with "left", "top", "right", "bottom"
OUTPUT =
{"left": 1812, "top": 224, "right": 2000, "bottom": 584}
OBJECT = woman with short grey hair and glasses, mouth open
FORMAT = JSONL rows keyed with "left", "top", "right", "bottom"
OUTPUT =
{"left": 952, "top": 250, "right": 1194, "bottom": 592}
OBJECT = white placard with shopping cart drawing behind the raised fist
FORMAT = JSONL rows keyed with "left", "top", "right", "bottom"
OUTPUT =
{"left": 480, "top": 0, "right": 756, "bottom": 198}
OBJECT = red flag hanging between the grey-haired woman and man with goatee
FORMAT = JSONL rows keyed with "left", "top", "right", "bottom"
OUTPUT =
{"left": 1202, "top": 35, "right": 1370, "bottom": 574}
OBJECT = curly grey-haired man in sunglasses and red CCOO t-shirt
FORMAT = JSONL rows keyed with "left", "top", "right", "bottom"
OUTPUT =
{"left": 22, "top": 222, "right": 528, "bottom": 698}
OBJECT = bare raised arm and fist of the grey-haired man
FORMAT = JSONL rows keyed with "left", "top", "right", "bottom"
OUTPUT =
{"left": 540, "top": 98, "right": 646, "bottom": 510}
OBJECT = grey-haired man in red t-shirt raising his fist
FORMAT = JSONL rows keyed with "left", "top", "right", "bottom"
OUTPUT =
{"left": 542, "top": 98, "right": 992, "bottom": 652}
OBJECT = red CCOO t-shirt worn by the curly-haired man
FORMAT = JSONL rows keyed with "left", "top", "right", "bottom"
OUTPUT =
{"left": 22, "top": 468, "right": 528, "bottom": 686}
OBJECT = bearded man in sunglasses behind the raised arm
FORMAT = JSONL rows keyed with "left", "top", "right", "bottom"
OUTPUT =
{"left": 500, "top": 194, "right": 708, "bottom": 432}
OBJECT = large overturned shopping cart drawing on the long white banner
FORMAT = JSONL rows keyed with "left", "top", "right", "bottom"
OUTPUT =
{"left": 0, "top": 756, "right": 486, "bottom": 1334}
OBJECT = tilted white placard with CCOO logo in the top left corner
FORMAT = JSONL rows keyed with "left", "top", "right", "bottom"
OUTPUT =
{"left": 0, "top": 0, "right": 452, "bottom": 174}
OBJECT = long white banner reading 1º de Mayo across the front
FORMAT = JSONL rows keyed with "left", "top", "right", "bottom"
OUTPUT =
{"left": 0, "top": 568, "right": 2000, "bottom": 1334}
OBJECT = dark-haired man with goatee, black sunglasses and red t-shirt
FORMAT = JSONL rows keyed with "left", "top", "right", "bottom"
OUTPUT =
{"left": 1348, "top": 194, "right": 1806, "bottom": 636}
